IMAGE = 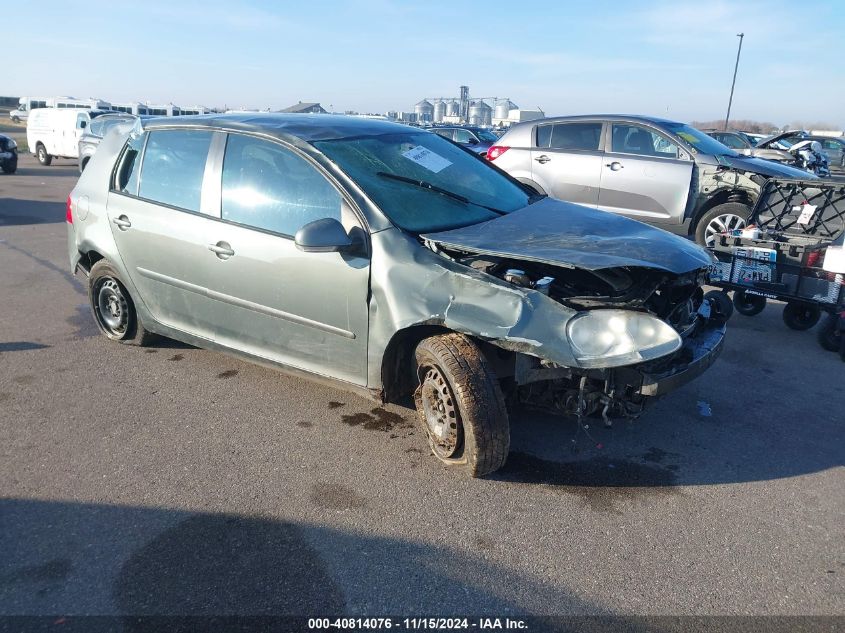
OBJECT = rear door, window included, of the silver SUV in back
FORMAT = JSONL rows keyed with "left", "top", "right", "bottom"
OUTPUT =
{"left": 531, "top": 121, "right": 603, "bottom": 207}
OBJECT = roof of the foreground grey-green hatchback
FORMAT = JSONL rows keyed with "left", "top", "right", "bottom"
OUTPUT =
{"left": 143, "top": 112, "right": 418, "bottom": 142}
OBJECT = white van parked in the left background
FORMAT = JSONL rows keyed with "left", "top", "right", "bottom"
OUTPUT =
{"left": 26, "top": 108, "right": 105, "bottom": 165}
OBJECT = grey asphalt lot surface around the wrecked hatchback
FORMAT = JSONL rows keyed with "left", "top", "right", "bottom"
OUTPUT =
{"left": 0, "top": 156, "right": 845, "bottom": 615}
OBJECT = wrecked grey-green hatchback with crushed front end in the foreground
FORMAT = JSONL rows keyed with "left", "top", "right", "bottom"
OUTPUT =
{"left": 67, "top": 114, "right": 725, "bottom": 476}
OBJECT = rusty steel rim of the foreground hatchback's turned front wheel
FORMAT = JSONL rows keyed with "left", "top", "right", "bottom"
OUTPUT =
{"left": 420, "top": 367, "right": 463, "bottom": 458}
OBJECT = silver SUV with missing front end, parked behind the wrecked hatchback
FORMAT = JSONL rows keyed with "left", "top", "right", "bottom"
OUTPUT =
{"left": 487, "top": 115, "right": 813, "bottom": 246}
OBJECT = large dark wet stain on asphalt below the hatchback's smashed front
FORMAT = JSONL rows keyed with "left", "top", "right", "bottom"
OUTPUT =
{"left": 493, "top": 452, "right": 683, "bottom": 514}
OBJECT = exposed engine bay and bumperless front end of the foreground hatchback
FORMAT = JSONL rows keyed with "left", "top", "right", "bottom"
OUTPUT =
{"left": 440, "top": 249, "right": 727, "bottom": 425}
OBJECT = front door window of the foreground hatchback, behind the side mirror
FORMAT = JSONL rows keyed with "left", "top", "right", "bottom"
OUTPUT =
{"left": 224, "top": 134, "right": 341, "bottom": 235}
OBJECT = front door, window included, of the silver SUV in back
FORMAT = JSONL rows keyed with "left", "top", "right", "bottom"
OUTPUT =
{"left": 598, "top": 122, "right": 693, "bottom": 224}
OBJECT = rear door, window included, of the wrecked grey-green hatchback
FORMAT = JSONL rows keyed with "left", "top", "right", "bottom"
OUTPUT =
{"left": 107, "top": 129, "right": 223, "bottom": 340}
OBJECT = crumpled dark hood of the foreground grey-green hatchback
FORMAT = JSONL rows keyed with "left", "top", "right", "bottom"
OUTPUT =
{"left": 422, "top": 198, "right": 712, "bottom": 274}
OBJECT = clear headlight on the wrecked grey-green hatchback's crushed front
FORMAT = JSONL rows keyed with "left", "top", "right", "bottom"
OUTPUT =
{"left": 566, "top": 310, "right": 681, "bottom": 367}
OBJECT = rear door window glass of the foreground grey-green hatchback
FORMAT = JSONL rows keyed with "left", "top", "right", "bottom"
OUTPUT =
{"left": 138, "top": 130, "right": 213, "bottom": 213}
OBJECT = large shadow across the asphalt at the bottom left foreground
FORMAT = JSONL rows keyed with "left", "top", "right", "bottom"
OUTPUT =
{"left": 0, "top": 498, "right": 608, "bottom": 620}
